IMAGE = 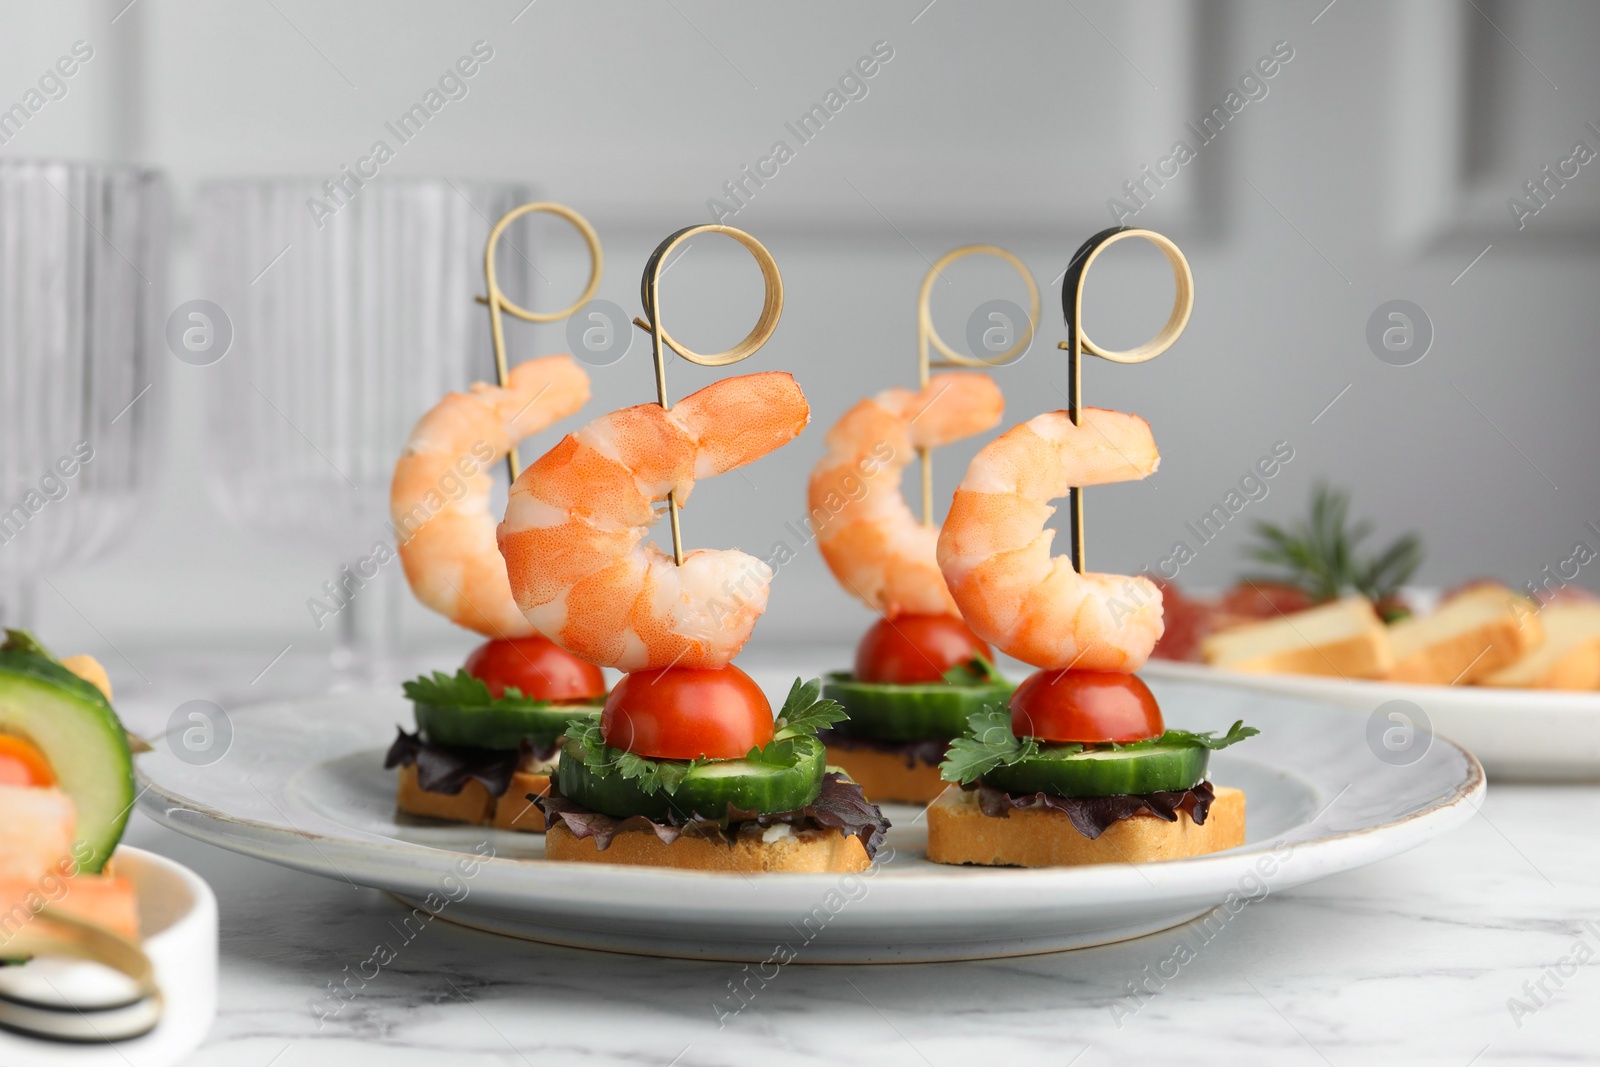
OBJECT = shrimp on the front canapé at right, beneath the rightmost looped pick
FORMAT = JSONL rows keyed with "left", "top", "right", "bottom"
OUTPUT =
{"left": 939, "top": 408, "right": 1162, "bottom": 672}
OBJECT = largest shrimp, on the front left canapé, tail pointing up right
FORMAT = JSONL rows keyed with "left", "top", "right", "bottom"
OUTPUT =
{"left": 499, "top": 371, "right": 811, "bottom": 670}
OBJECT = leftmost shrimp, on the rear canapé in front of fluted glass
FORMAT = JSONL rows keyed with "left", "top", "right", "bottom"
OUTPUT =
{"left": 389, "top": 355, "right": 589, "bottom": 637}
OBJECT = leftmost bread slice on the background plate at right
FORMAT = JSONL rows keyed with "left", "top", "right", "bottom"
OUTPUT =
{"left": 1200, "top": 597, "right": 1394, "bottom": 678}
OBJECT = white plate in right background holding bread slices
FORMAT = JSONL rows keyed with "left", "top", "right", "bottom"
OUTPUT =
{"left": 1141, "top": 659, "right": 1600, "bottom": 782}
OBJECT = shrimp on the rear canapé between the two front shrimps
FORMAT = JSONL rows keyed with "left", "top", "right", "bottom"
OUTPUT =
{"left": 808, "top": 371, "right": 1005, "bottom": 617}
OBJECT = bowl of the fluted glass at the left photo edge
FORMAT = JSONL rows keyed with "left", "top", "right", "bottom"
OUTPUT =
{"left": 0, "top": 160, "right": 168, "bottom": 625}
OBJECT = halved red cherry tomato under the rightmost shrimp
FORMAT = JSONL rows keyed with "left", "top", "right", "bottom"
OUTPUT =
{"left": 1011, "top": 670, "right": 1166, "bottom": 744}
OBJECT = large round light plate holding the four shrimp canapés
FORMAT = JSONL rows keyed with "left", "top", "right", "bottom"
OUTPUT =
{"left": 139, "top": 670, "right": 1483, "bottom": 963}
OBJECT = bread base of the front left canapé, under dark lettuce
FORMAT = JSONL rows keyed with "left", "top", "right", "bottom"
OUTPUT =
{"left": 544, "top": 822, "right": 872, "bottom": 873}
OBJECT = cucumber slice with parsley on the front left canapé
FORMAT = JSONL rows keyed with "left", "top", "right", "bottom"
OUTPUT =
{"left": 555, "top": 737, "right": 826, "bottom": 819}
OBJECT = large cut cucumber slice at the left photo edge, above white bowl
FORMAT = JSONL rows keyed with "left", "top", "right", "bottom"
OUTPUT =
{"left": 0, "top": 651, "right": 134, "bottom": 873}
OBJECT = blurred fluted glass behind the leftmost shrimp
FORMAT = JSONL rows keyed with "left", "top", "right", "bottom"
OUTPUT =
{"left": 197, "top": 176, "right": 531, "bottom": 681}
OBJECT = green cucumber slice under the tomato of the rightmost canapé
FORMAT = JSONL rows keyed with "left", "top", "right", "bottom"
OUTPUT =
{"left": 984, "top": 744, "right": 1211, "bottom": 797}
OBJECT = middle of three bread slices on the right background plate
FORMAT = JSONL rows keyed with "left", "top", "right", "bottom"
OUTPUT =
{"left": 1389, "top": 584, "right": 1544, "bottom": 685}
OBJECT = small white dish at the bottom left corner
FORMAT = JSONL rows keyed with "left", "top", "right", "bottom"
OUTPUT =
{"left": 0, "top": 845, "right": 216, "bottom": 1067}
